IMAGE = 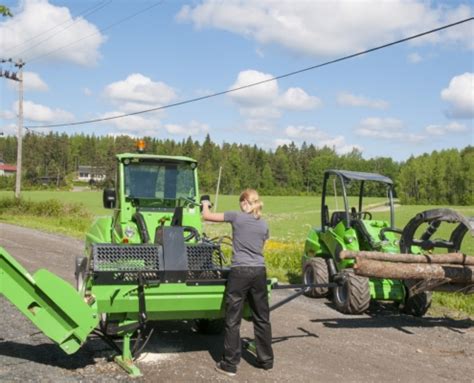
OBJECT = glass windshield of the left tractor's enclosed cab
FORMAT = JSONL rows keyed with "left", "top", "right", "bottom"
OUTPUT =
{"left": 124, "top": 161, "right": 196, "bottom": 206}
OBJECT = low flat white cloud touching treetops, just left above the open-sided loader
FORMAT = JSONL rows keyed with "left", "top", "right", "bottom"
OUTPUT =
{"left": 274, "top": 125, "right": 362, "bottom": 154}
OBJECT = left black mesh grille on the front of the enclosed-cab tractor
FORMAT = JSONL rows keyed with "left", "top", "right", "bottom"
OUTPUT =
{"left": 93, "top": 245, "right": 162, "bottom": 272}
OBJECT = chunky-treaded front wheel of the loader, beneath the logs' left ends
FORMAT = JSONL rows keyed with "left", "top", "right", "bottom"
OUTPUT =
{"left": 333, "top": 270, "right": 370, "bottom": 314}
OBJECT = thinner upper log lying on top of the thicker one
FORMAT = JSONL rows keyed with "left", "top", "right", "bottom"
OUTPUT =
{"left": 340, "top": 250, "right": 474, "bottom": 266}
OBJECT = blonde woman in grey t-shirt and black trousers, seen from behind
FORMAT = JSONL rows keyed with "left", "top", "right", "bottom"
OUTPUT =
{"left": 202, "top": 189, "right": 273, "bottom": 376}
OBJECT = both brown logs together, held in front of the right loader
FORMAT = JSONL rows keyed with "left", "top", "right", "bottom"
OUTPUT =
{"left": 340, "top": 250, "right": 474, "bottom": 285}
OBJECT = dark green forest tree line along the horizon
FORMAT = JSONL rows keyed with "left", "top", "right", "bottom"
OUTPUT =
{"left": 0, "top": 133, "right": 474, "bottom": 205}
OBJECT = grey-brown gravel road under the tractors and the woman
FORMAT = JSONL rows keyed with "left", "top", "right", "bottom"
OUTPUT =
{"left": 0, "top": 223, "right": 474, "bottom": 383}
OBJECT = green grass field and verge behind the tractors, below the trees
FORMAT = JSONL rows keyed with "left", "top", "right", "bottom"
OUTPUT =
{"left": 0, "top": 191, "right": 474, "bottom": 316}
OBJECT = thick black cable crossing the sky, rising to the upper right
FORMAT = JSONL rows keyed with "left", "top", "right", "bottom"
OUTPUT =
{"left": 28, "top": 17, "right": 474, "bottom": 129}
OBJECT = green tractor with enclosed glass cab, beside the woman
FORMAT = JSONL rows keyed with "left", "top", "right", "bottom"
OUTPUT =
{"left": 75, "top": 153, "right": 235, "bottom": 373}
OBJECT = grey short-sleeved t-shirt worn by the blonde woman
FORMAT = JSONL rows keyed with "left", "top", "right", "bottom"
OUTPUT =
{"left": 224, "top": 211, "right": 269, "bottom": 267}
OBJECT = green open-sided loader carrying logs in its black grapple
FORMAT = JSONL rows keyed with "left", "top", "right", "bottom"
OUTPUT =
{"left": 302, "top": 170, "right": 474, "bottom": 316}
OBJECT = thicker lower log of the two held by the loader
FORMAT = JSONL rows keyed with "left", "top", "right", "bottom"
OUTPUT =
{"left": 354, "top": 257, "right": 474, "bottom": 283}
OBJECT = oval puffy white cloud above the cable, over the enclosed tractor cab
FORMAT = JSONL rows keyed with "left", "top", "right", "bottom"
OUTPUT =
{"left": 104, "top": 73, "right": 177, "bottom": 111}
